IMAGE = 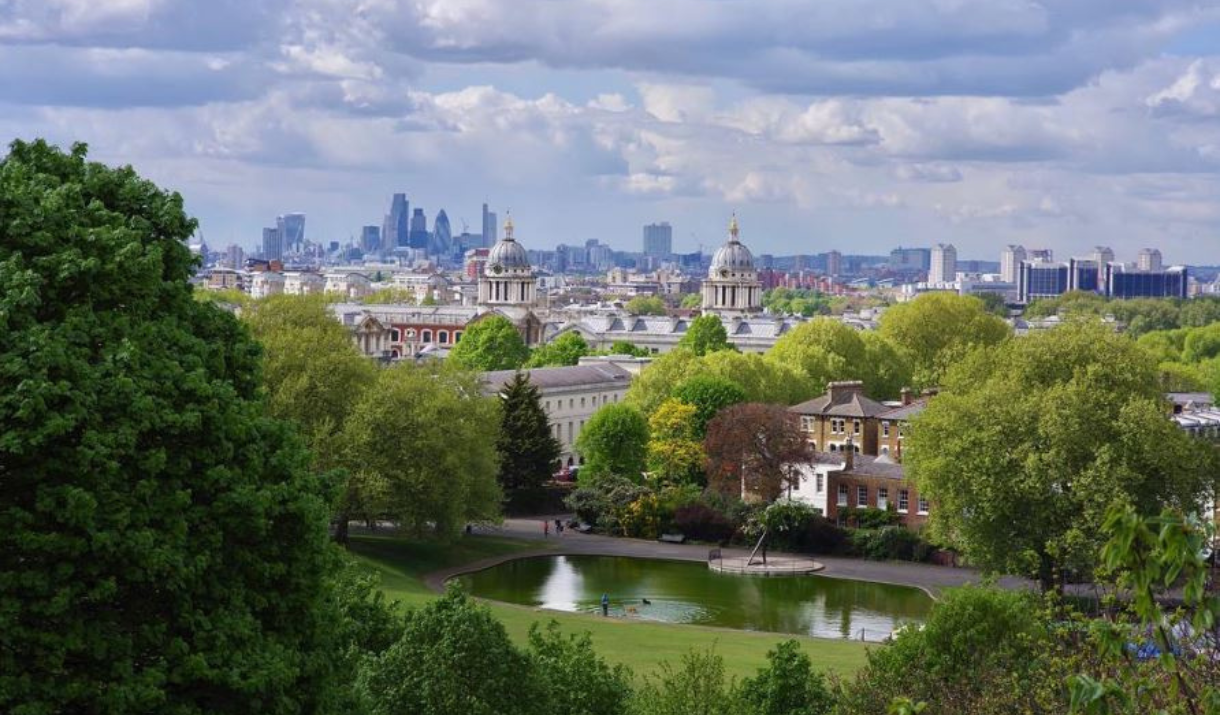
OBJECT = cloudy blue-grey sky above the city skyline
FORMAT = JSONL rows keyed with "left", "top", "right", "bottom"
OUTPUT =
{"left": 7, "top": 0, "right": 1220, "bottom": 264}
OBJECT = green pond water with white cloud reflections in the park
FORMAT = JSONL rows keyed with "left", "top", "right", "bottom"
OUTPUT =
{"left": 459, "top": 556, "right": 932, "bottom": 641}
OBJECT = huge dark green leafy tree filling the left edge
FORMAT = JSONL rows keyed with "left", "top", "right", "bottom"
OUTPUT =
{"left": 0, "top": 142, "right": 334, "bottom": 714}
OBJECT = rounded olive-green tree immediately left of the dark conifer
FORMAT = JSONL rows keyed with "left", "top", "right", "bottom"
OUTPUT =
{"left": 343, "top": 364, "right": 501, "bottom": 537}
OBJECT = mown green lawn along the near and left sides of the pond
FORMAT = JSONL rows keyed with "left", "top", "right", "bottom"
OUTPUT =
{"left": 351, "top": 536, "right": 866, "bottom": 677}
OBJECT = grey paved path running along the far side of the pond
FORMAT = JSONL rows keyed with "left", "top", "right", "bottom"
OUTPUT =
{"left": 425, "top": 515, "right": 1035, "bottom": 598}
